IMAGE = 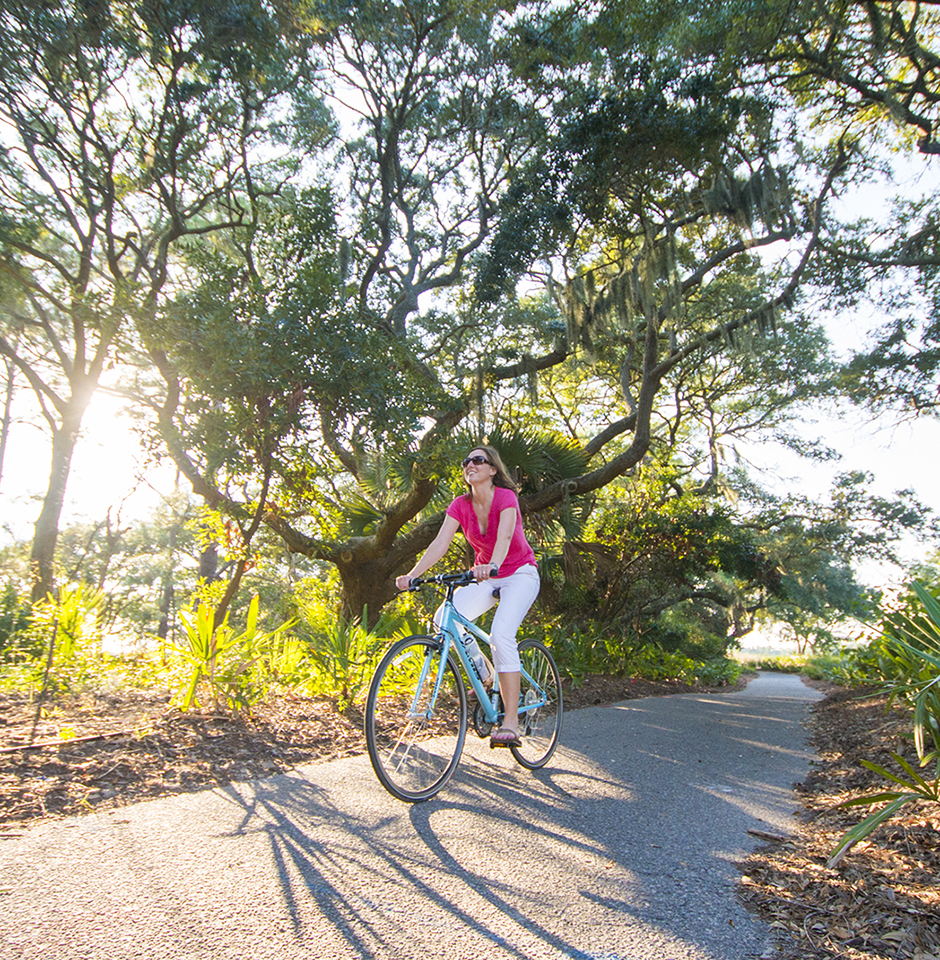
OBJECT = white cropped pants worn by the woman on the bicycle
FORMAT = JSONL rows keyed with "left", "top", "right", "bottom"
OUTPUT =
{"left": 434, "top": 563, "right": 541, "bottom": 673}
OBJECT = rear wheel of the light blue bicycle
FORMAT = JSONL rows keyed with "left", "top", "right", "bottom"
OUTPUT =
{"left": 509, "top": 640, "right": 564, "bottom": 770}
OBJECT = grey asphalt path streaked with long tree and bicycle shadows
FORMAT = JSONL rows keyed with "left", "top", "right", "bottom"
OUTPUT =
{"left": 0, "top": 674, "right": 818, "bottom": 960}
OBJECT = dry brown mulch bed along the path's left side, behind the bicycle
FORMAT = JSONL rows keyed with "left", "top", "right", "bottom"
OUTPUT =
{"left": 0, "top": 677, "right": 693, "bottom": 831}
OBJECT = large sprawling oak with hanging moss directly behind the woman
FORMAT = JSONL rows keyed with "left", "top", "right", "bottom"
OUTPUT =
{"left": 145, "top": 2, "right": 868, "bottom": 616}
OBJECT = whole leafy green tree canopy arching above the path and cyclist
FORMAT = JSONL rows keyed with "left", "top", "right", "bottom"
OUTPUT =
{"left": 0, "top": 0, "right": 935, "bottom": 644}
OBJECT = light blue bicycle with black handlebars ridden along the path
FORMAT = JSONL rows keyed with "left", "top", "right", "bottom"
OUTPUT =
{"left": 365, "top": 573, "right": 563, "bottom": 803}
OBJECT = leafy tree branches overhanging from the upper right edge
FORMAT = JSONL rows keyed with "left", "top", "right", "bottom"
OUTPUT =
{"left": 530, "top": 0, "right": 940, "bottom": 424}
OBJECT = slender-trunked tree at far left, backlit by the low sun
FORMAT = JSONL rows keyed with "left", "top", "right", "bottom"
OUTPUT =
{"left": 0, "top": 0, "right": 314, "bottom": 598}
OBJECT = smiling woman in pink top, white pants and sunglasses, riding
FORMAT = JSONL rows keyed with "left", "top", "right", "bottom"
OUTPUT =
{"left": 395, "top": 447, "right": 540, "bottom": 747}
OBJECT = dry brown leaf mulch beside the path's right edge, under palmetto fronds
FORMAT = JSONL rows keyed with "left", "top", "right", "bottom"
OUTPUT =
{"left": 740, "top": 690, "right": 940, "bottom": 960}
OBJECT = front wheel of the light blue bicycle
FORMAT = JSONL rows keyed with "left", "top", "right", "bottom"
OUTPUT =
{"left": 365, "top": 637, "right": 467, "bottom": 803}
